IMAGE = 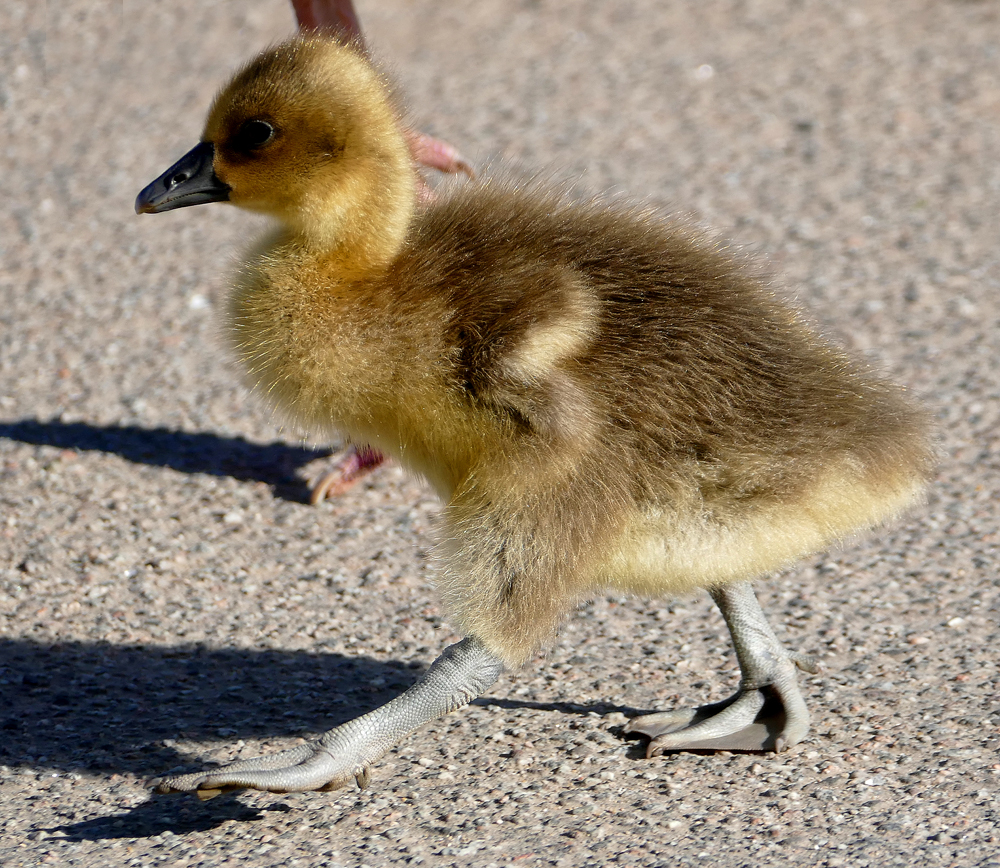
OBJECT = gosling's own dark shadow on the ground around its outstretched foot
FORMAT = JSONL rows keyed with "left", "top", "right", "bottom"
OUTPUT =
{"left": 0, "top": 639, "right": 634, "bottom": 840}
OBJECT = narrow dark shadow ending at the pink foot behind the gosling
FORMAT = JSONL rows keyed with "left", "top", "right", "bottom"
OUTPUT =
{"left": 0, "top": 419, "right": 331, "bottom": 503}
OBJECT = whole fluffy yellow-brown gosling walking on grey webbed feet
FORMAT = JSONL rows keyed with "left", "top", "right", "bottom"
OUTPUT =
{"left": 136, "top": 38, "right": 933, "bottom": 797}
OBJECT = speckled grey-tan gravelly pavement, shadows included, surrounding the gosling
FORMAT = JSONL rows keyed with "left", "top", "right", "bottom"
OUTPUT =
{"left": 0, "top": 0, "right": 1000, "bottom": 868}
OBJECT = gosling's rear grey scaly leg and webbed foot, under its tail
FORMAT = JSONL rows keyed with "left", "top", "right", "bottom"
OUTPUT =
{"left": 625, "top": 582, "right": 818, "bottom": 757}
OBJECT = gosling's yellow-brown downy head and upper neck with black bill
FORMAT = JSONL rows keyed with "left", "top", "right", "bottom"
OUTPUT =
{"left": 135, "top": 37, "right": 415, "bottom": 259}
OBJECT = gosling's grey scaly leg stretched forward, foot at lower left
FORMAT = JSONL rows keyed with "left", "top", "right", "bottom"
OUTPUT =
{"left": 150, "top": 637, "right": 503, "bottom": 800}
